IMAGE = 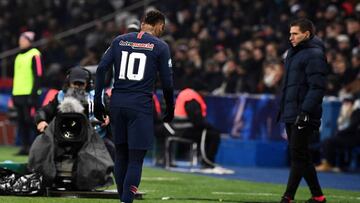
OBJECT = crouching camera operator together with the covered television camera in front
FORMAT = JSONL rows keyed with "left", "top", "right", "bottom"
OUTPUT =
{"left": 28, "top": 67, "right": 113, "bottom": 190}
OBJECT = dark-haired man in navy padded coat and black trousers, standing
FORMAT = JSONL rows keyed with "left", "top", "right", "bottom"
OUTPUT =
{"left": 279, "top": 19, "right": 328, "bottom": 203}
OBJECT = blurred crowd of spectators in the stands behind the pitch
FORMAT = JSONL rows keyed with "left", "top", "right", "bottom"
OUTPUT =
{"left": 0, "top": 0, "right": 360, "bottom": 96}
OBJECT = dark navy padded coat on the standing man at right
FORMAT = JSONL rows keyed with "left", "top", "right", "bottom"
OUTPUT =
{"left": 280, "top": 37, "right": 329, "bottom": 126}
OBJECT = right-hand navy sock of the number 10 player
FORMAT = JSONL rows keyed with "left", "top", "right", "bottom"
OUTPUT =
{"left": 121, "top": 150, "right": 146, "bottom": 203}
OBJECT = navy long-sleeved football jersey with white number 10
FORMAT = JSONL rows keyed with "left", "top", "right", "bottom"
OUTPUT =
{"left": 95, "top": 32, "right": 173, "bottom": 113}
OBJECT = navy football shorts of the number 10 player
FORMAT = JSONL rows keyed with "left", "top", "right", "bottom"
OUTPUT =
{"left": 110, "top": 107, "right": 154, "bottom": 149}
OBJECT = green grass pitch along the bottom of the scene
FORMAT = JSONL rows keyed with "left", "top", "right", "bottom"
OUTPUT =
{"left": 0, "top": 146, "right": 360, "bottom": 203}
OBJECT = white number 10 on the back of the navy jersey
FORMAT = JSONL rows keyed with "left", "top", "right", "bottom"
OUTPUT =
{"left": 119, "top": 51, "right": 146, "bottom": 81}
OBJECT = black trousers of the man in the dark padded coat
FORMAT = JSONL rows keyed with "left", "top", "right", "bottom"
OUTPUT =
{"left": 284, "top": 123, "right": 323, "bottom": 199}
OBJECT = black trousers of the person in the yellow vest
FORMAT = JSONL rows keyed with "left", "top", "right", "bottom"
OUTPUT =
{"left": 13, "top": 95, "right": 35, "bottom": 149}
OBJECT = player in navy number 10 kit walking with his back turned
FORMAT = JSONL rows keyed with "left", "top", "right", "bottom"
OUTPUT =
{"left": 94, "top": 11, "right": 174, "bottom": 203}
